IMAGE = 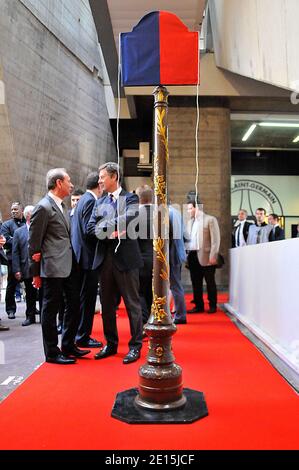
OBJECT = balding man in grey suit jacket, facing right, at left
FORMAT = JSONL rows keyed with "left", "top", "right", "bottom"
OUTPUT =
{"left": 29, "top": 168, "right": 90, "bottom": 364}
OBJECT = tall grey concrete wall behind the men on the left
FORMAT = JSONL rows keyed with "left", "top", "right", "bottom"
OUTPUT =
{"left": 0, "top": 0, "right": 115, "bottom": 217}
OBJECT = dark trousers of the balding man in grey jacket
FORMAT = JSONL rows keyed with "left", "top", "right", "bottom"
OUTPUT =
{"left": 41, "top": 266, "right": 80, "bottom": 358}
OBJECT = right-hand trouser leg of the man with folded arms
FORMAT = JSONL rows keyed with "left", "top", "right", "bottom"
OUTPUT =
{"left": 114, "top": 268, "right": 142, "bottom": 349}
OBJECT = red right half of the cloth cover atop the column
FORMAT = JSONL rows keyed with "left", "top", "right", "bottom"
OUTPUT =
{"left": 159, "top": 11, "right": 198, "bottom": 85}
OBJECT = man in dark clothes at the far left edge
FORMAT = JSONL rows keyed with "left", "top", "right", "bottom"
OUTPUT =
{"left": 1, "top": 202, "right": 25, "bottom": 319}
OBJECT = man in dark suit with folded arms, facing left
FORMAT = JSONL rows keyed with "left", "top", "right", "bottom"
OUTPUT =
{"left": 87, "top": 162, "right": 142, "bottom": 364}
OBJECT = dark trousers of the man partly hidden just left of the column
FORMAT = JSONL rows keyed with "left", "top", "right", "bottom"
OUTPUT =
{"left": 139, "top": 256, "right": 153, "bottom": 324}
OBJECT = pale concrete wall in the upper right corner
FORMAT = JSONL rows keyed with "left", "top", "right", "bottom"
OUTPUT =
{"left": 209, "top": 0, "right": 299, "bottom": 90}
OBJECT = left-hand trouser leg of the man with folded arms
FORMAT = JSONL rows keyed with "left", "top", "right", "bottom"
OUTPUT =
{"left": 100, "top": 251, "right": 120, "bottom": 348}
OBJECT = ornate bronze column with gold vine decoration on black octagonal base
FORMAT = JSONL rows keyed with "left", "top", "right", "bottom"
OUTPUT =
{"left": 112, "top": 86, "right": 208, "bottom": 424}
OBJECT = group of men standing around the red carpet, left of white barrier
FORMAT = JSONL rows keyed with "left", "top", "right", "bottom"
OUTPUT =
{"left": 0, "top": 162, "right": 225, "bottom": 364}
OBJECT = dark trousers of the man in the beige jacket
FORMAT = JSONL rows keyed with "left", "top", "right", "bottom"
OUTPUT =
{"left": 188, "top": 251, "right": 217, "bottom": 310}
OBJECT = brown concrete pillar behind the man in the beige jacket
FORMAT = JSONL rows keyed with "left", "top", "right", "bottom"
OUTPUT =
{"left": 168, "top": 99, "right": 231, "bottom": 287}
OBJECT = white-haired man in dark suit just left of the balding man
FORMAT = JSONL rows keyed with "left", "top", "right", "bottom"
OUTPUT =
{"left": 12, "top": 206, "right": 37, "bottom": 326}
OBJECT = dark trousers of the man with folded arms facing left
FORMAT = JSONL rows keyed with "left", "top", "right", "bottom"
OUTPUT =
{"left": 100, "top": 250, "right": 142, "bottom": 349}
